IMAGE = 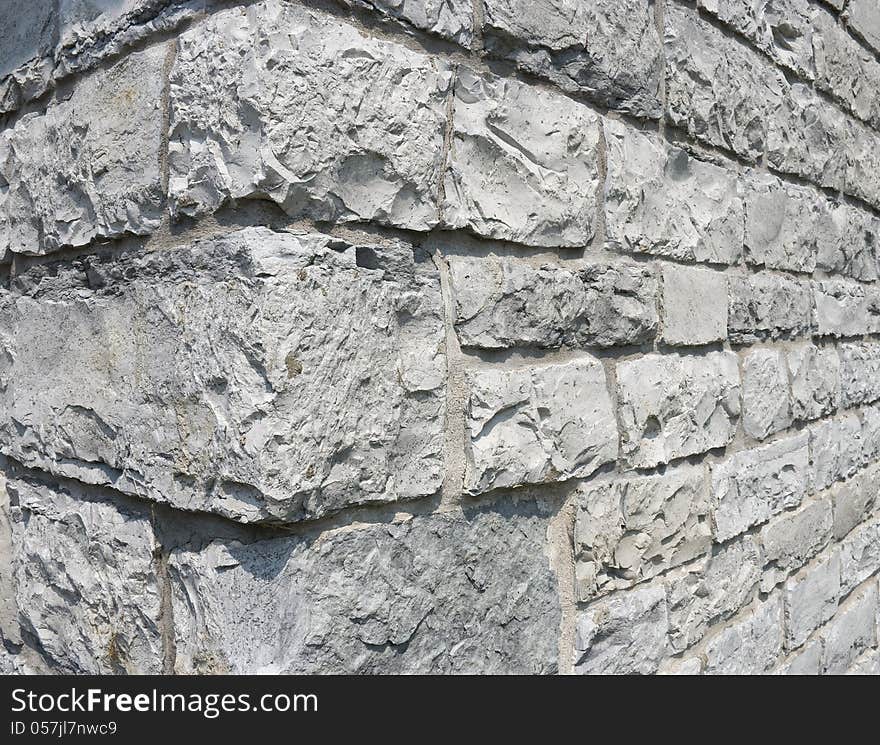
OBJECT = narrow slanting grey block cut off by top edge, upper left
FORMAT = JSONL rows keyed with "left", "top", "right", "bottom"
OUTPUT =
{"left": 54, "top": 0, "right": 208, "bottom": 78}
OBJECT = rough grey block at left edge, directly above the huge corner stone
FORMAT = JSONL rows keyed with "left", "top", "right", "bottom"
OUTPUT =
{"left": 0, "top": 45, "right": 166, "bottom": 255}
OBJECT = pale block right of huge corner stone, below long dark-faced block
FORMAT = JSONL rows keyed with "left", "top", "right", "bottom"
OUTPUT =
{"left": 465, "top": 357, "right": 618, "bottom": 493}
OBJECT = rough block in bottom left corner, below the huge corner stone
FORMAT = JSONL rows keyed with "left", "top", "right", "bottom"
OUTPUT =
{"left": 8, "top": 481, "right": 162, "bottom": 675}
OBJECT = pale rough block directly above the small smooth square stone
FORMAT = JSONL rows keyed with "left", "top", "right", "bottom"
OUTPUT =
{"left": 603, "top": 119, "right": 744, "bottom": 264}
